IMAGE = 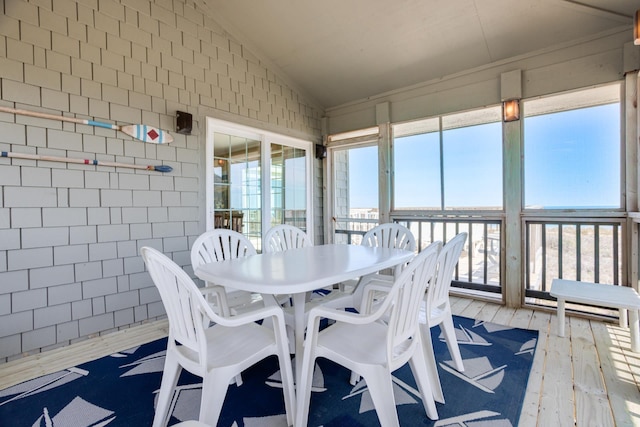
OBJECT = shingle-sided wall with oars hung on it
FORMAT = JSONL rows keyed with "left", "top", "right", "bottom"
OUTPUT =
{"left": 0, "top": 0, "right": 321, "bottom": 362}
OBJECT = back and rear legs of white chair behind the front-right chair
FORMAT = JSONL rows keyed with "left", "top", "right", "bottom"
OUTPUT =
{"left": 420, "top": 232, "right": 467, "bottom": 376}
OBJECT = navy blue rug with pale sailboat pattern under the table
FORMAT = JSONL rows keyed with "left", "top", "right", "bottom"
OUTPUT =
{"left": 0, "top": 316, "right": 538, "bottom": 427}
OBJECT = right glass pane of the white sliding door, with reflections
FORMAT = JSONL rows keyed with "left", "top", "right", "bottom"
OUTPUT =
{"left": 270, "top": 144, "right": 307, "bottom": 231}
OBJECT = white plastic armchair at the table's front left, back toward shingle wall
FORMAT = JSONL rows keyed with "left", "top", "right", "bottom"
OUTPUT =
{"left": 140, "top": 247, "right": 295, "bottom": 427}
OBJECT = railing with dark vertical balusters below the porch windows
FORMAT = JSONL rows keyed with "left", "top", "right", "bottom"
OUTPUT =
{"left": 335, "top": 216, "right": 626, "bottom": 303}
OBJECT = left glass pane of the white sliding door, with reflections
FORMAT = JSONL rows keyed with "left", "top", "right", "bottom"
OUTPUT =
{"left": 213, "top": 132, "right": 262, "bottom": 246}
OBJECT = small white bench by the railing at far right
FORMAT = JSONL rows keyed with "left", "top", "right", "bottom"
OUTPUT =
{"left": 549, "top": 279, "right": 640, "bottom": 352}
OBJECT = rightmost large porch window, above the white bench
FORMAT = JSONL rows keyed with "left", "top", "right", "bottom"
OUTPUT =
{"left": 523, "top": 84, "right": 622, "bottom": 209}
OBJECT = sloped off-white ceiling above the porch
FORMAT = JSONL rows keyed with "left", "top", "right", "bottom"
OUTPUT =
{"left": 204, "top": 0, "right": 640, "bottom": 108}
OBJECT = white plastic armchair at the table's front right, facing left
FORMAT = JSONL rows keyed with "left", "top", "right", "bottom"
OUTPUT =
{"left": 295, "top": 242, "right": 441, "bottom": 427}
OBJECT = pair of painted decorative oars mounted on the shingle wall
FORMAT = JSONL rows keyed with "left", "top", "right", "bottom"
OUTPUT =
{"left": 0, "top": 106, "right": 173, "bottom": 172}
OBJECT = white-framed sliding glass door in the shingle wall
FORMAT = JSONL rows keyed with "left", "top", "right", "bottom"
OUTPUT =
{"left": 206, "top": 118, "right": 313, "bottom": 251}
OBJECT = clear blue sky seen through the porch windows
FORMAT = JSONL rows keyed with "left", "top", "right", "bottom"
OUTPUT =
{"left": 349, "top": 104, "right": 620, "bottom": 209}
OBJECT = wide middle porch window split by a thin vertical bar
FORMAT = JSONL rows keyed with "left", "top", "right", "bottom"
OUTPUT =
{"left": 393, "top": 107, "right": 502, "bottom": 210}
